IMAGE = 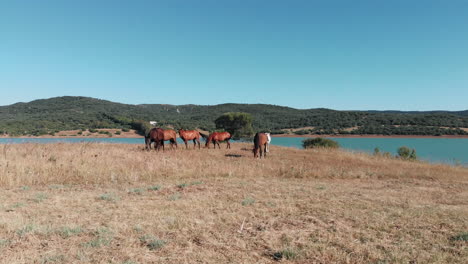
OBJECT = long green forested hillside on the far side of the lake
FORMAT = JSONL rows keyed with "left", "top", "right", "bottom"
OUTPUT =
{"left": 0, "top": 96, "right": 468, "bottom": 135}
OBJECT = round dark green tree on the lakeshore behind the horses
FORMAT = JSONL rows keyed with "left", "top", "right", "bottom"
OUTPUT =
{"left": 215, "top": 112, "right": 254, "bottom": 139}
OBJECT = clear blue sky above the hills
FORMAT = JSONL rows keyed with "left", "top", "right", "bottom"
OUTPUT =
{"left": 0, "top": 0, "right": 468, "bottom": 110}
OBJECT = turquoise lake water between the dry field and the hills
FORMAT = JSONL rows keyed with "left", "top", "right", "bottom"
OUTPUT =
{"left": 0, "top": 137, "right": 468, "bottom": 166}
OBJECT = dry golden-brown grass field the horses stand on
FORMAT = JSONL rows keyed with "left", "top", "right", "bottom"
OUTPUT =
{"left": 0, "top": 143, "right": 468, "bottom": 264}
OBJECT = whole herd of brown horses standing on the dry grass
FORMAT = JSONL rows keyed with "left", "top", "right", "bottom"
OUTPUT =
{"left": 145, "top": 127, "right": 271, "bottom": 158}
